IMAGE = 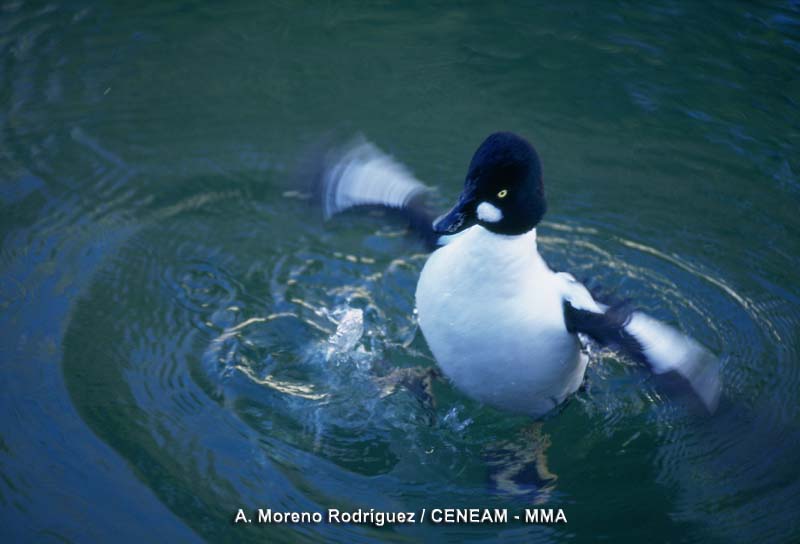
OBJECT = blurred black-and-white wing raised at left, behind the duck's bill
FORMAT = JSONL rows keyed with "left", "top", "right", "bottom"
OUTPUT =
{"left": 314, "top": 138, "right": 439, "bottom": 250}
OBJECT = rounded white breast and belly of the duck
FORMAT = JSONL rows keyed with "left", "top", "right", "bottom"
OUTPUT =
{"left": 416, "top": 226, "right": 586, "bottom": 416}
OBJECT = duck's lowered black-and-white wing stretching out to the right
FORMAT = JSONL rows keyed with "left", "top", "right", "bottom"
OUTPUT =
{"left": 564, "top": 275, "right": 721, "bottom": 413}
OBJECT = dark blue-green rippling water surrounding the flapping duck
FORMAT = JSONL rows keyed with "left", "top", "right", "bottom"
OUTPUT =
{"left": 0, "top": 1, "right": 800, "bottom": 542}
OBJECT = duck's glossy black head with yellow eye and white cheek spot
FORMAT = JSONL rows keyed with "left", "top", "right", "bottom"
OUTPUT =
{"left": 433, "top": 132, "right": 547, "bottom": 235}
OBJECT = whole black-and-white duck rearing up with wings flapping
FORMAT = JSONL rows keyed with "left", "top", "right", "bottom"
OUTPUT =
{"left": 314, "top": 132, "right": 721, "bottom": 418}
